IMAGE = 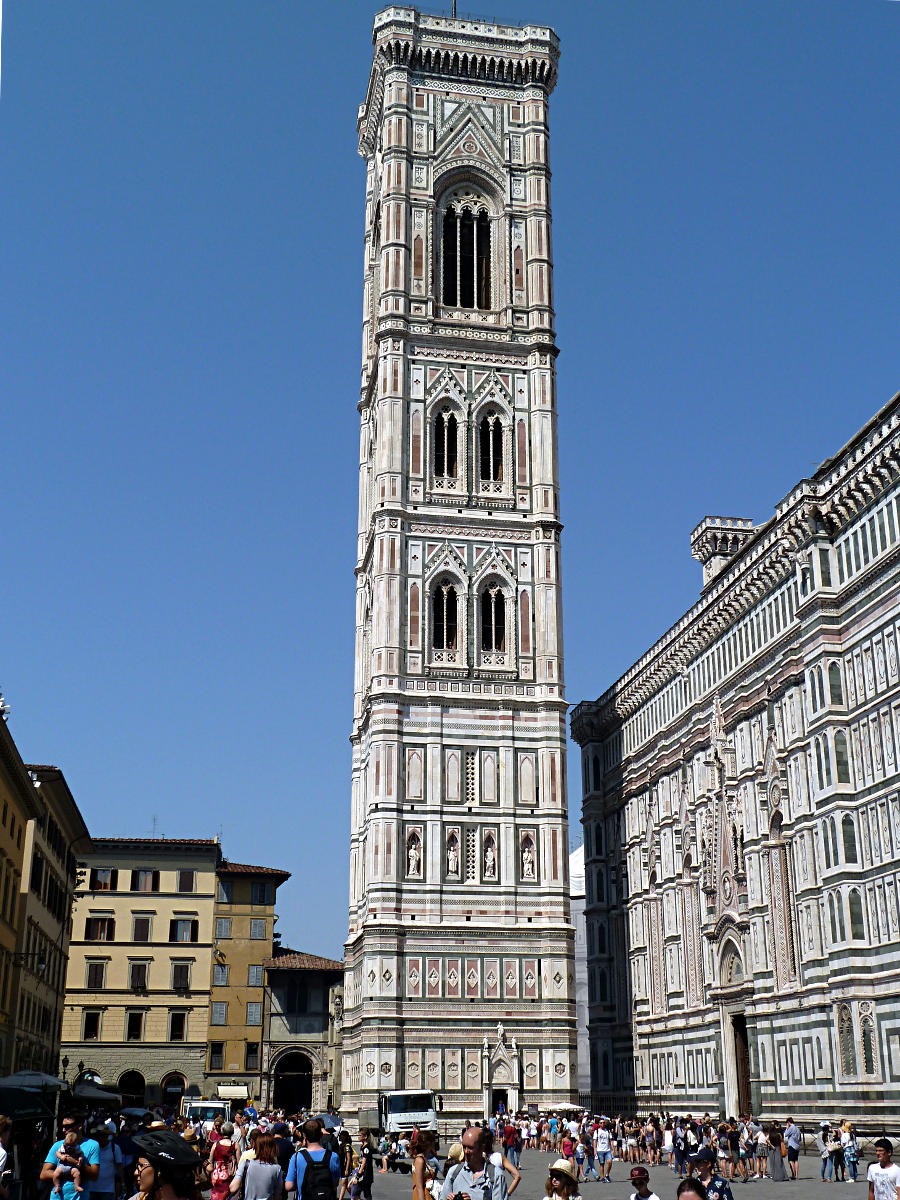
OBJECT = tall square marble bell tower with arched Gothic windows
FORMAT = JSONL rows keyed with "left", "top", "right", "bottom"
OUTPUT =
{"left": 343, "top": 7, "right": 576, "bottom": 1116}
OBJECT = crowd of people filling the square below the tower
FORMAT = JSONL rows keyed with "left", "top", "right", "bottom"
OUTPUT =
{"left": 7, "top": 1109, "right": 900, "bottom": 1200}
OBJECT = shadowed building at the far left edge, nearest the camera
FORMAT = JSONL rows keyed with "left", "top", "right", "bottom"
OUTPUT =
{"left": 0, "top": 715, "right": 41, "bottom": 1075}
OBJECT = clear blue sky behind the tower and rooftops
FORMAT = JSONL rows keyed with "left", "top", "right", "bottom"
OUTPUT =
{"left": 0, "top": 0, "right": 900, "bottom": 954}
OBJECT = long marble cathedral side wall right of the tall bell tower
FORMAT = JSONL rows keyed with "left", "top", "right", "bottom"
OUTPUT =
{"left": 572, "top": 396, "right": 900, "bottom": 1127}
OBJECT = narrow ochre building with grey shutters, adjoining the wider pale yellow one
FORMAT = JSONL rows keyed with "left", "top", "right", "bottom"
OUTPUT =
{"left": 206, "top": 859, "right": 290, "bottom": 1103}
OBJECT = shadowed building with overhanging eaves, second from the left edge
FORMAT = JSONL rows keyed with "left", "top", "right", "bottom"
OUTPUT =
{"left": 12, "top": 767, "right": 90, "bottom": 1074}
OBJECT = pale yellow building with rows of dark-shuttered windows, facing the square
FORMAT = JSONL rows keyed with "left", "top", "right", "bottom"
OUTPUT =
{"left": 61, "top": 838, "right": 219, "bottom": 1105}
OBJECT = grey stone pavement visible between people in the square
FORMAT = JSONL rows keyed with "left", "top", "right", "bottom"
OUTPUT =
{"left": 372, "top": 1138, "right": 871, "bottom": 1200}
